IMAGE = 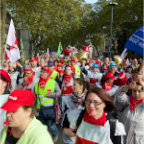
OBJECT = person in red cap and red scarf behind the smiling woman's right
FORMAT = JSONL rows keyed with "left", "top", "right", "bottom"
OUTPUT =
{"left": 96, "top": 72, "right": 119, "bottom": 96}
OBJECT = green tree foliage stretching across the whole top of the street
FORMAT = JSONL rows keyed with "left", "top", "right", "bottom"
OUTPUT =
{"left": 7, "top": 0, "right": 143, "bottom": 55}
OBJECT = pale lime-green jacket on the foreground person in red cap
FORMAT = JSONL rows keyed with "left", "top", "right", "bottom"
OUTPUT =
{"left": 0, "top": 117, "right": 53, "bottom": 144}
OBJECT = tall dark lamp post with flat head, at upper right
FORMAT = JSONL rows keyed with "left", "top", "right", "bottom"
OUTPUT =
{"left": 108, "top": 2, "right": 118, "bottom": 58}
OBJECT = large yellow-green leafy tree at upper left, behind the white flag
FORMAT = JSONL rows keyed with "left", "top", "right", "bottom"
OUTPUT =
{"left": 7, "top": 0, "right": 84, "bottom": 56}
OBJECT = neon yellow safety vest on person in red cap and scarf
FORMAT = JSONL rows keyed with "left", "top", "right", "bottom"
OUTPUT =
{"left": 35, "top": 79, "right": 55, "bottom": 109}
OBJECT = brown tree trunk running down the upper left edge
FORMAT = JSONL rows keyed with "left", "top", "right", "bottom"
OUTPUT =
{"left": 0, "top": 0, "right": 6, "bottom": 62}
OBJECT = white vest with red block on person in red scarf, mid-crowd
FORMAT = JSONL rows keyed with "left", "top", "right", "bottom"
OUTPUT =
{"left": 62, "top": 78, "right": 74, "bottom": 96}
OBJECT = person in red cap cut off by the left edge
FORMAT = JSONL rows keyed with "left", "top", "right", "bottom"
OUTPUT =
{"left": 0, "top": 69, "right": 11, "bottom": 134}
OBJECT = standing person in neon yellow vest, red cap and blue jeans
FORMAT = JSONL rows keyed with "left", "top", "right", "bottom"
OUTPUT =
{"left": 35, "top": 66, "right": 61, "bottom": 142}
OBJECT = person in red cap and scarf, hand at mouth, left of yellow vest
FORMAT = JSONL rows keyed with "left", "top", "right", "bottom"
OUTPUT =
{"left": 18, "top": 67, "right": 39, "bottom": 93}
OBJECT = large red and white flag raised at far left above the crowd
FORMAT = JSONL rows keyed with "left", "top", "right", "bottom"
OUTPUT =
{"left": 6, "top": 19, "right": 20, "bottom": 63}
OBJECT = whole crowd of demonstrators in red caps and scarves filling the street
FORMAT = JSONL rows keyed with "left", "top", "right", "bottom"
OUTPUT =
{"left": 0, "top": 51, "right": 144, "bottom": 144}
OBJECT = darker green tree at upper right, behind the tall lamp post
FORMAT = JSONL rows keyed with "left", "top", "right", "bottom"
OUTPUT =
{"left": 86, "top": 0, "right": 143, "bottom": 53}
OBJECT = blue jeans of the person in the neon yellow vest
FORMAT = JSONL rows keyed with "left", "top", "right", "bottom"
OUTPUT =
{"left": 40, "top": 119, "right": 58, "bottom": 137}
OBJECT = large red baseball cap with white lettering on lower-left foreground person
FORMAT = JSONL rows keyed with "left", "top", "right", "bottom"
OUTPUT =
{"left": 1, "top": 89, "right": 36, "bottom": 112}
